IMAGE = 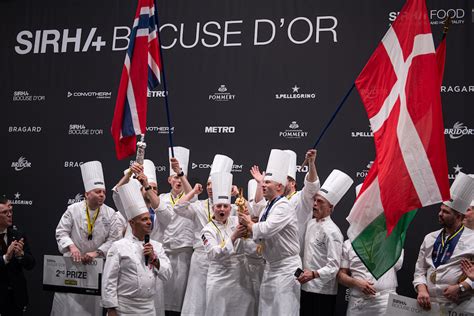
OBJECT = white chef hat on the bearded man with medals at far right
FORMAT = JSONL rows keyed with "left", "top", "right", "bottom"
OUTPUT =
{"left": 443, "top": 172, "right": 474, "bottom": 214}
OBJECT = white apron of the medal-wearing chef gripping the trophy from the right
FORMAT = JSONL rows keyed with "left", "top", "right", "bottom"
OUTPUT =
{"left": 258, "top": 255, "right": 302, "bottom": 316}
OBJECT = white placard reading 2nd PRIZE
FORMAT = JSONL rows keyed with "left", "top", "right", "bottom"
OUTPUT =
{"left": 43, "top": 255, "right": 104, "bottom": 295}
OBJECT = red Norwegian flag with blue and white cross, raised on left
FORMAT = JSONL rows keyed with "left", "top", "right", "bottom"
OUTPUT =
{"left": 111, "top": 0, "right": 162, "bottom": 159}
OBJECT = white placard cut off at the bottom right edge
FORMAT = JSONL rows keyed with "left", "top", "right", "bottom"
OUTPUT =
{"left": 386, "top": 294, "right": 474, "bottom": 316}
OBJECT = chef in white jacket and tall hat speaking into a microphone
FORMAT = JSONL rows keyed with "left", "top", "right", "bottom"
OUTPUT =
{"left": 102, "top": 183, "right": 172, "bottom": 316}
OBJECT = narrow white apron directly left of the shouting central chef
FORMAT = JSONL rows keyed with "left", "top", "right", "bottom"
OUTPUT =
{"left": 181, "top": 247, "right": 209, "bottom": 316}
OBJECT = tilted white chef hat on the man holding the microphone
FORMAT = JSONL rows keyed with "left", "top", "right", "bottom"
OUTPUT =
{"left": 117, "top": 182, "right": 148, "bottom": 220}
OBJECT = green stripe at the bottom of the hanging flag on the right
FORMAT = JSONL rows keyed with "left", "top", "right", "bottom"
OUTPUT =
{"left": 352, "top": 210, "right": 417, "bottom": 280}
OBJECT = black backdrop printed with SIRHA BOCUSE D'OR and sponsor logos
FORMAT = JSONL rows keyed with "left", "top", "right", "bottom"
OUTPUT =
{"left": 0, "top": 0, "right": 474, "bottom": 315}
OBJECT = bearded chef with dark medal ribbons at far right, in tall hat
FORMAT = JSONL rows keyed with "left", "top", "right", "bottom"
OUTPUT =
{"left": 413, "top": 172, "right": 474, "bottom": 311}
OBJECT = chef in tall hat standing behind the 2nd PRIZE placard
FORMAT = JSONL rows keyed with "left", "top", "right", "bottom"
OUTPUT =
{"left": 51, "top": 161, "right": 122, "bottom": 316}
